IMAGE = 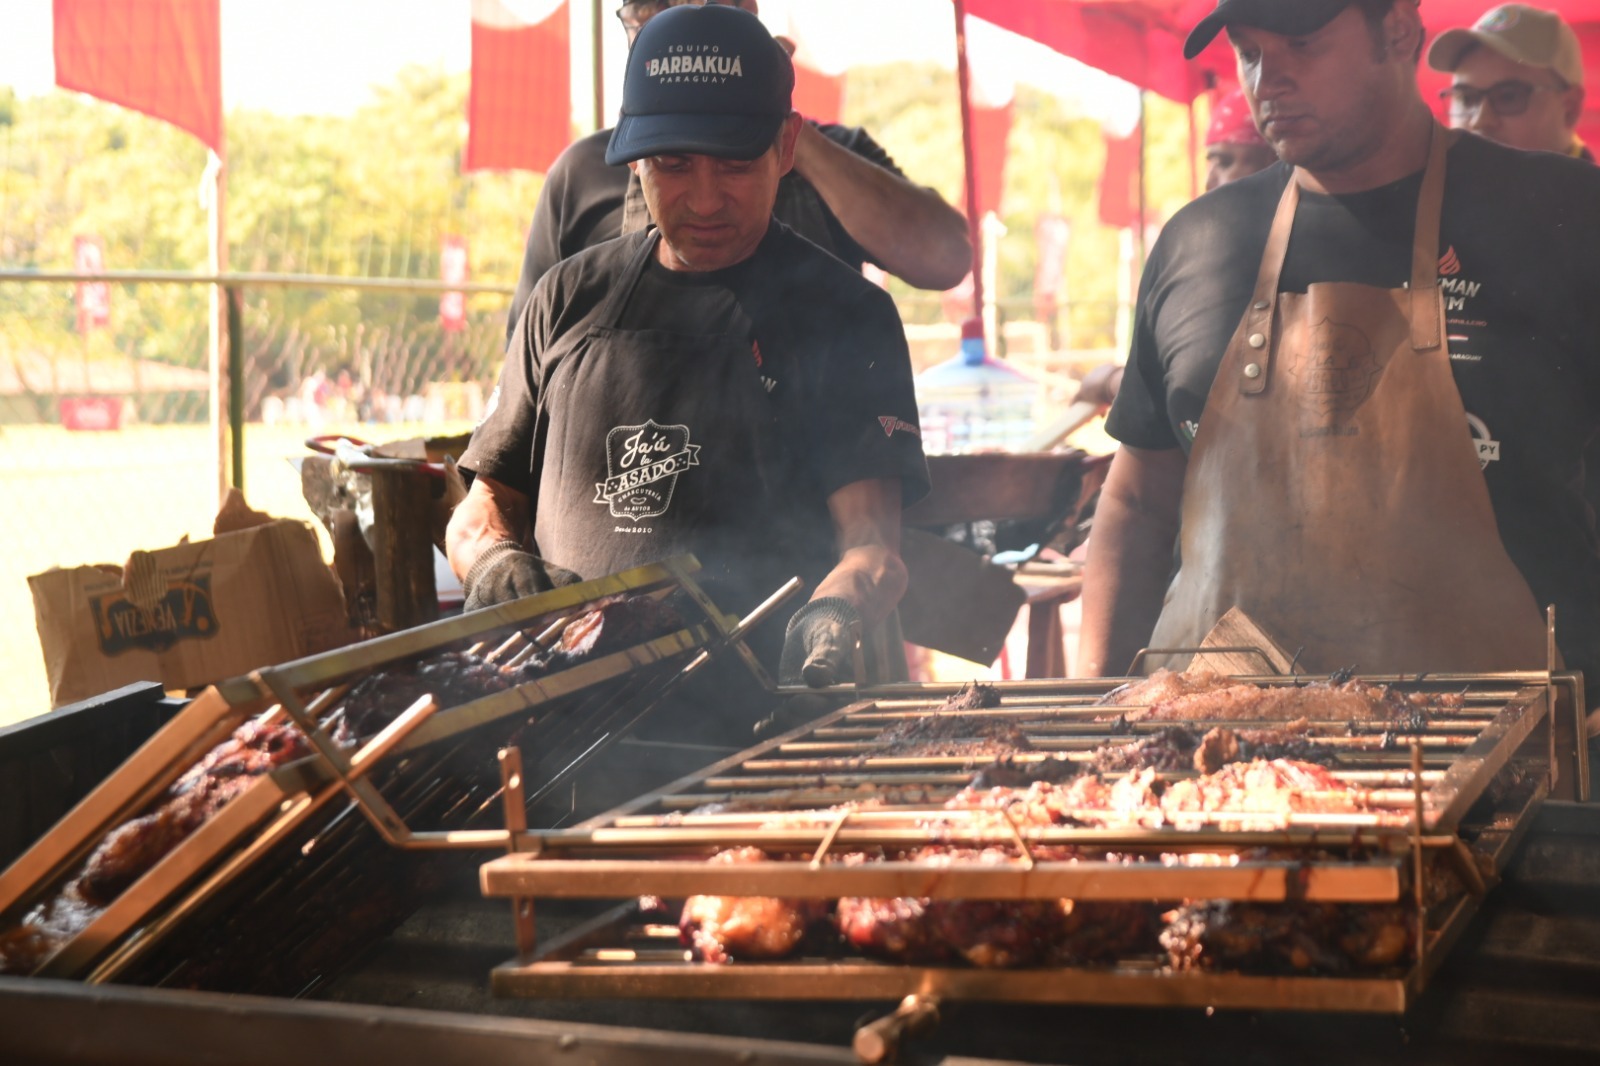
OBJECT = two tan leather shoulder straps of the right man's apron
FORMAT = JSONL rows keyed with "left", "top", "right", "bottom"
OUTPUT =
{"left": 1246, "top": 122, "right": 1450, "bottom": 352}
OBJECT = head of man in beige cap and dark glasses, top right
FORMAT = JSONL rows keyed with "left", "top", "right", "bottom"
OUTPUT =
{"left": 1427, "top": 3, "right": 1595, "bottom": 163}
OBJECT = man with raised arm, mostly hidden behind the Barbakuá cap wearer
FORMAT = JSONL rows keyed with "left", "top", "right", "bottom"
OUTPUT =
{"left": 506, "top": 0, "right": 973, "bottom": 341}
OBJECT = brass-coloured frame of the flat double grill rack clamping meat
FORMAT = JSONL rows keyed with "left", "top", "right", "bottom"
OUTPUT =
{"left": 480, "top": 672, "right": 1555, "bottom": 1013}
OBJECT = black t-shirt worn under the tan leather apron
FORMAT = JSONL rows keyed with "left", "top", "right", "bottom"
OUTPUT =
{"left": 1107, "top": 134, "right": 1600, "bottom": 685}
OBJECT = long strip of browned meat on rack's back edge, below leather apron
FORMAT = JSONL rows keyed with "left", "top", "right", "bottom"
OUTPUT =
{"left": 1098, "top": 671, "right": 1461, "bottom": 728}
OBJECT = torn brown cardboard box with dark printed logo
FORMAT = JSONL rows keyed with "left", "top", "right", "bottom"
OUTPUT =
{"left": 27, "top": 519, "right": 355, "bottom": 707}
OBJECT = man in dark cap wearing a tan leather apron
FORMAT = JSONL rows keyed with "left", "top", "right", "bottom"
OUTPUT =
{"left": 1080, "top": 0, "right": 1600, "bottom": 691}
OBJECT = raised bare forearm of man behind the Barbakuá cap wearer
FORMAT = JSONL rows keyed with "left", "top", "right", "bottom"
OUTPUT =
{"left": 795, "top": 123, "right": 973, "bottom": 290}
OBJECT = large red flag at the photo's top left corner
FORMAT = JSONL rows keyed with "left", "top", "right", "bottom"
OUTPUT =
{"left": 54, "top": 0, "right": 222, "bottom": 155}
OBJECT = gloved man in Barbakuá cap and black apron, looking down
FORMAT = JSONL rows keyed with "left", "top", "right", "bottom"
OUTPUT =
{"left": 448, "top": 6, "right": 928, "bottom": 697}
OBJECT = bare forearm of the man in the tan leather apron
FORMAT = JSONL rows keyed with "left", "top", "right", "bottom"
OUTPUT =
{"left": 1075, "top": 450, "right": 1182, "bottom": 677}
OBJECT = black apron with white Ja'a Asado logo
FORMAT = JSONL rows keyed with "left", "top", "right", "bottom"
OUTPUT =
{"left": 534, "top": 232, "right": 834, "bottom": 664}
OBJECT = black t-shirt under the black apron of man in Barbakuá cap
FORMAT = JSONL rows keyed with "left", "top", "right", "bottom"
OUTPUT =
{"left": 461, "top": 221, "right": 928, "bottom": 607}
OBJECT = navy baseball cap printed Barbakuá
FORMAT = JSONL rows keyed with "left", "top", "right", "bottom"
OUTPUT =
{"left": 605, "top": 3, "right": 795, "bottom": 166}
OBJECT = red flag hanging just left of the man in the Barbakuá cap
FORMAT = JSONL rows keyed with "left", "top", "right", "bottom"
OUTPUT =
{"left": 461, "top": 0, "right": 573, "bottom": 173}
